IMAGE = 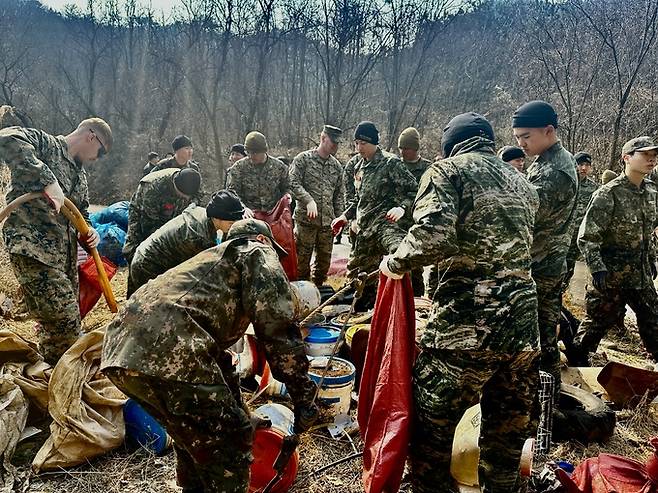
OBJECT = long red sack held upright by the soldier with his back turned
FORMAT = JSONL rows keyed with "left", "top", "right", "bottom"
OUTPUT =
{"left": 358, "top": 274, "right": 416, "bottom": 493}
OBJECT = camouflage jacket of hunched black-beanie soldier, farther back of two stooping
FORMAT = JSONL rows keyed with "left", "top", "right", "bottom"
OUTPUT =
{"left": 123, "top": 168, "right": 192, "bottom": 262}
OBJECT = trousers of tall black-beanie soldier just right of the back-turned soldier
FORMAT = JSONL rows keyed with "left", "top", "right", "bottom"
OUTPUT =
{"left": 533, "top": 276, "right": 563, "bottom": 394}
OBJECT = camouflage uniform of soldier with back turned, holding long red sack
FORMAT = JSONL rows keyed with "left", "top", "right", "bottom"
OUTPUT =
{"left": 388, "top": 137, "right": 539, "bottom": 493}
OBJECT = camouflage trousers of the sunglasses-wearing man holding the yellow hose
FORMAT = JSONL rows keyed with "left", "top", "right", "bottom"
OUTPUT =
{"left": 10, "top": 254, "right": 81, "bottom": 366}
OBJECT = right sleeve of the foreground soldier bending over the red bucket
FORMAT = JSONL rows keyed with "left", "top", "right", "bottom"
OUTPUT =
{"left": 242, "top": 248, "right": 315, "bottom": 405}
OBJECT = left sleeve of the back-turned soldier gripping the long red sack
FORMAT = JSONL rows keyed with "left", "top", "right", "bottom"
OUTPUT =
{"left": 388, "top": 167, "right": 460, "bottom": 274}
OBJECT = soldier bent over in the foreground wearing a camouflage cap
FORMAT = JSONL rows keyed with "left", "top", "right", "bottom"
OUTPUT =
{"left": 101, "top": 219, "right": 318, "bottom": 493}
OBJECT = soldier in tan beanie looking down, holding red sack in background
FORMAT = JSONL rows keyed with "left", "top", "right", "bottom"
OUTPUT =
{"left": 226, "top": 132, "right": 290, "bottom": 217}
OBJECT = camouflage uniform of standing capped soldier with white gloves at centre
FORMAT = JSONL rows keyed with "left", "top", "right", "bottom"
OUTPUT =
{"left": 289, "top": 149, "right": 345, "bottom": 286}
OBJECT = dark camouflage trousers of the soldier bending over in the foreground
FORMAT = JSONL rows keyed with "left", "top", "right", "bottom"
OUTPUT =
{"left": 104, "top": 368, "right": 253, "bottom": 493}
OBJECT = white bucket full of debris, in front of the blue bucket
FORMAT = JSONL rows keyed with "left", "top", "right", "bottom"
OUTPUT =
{"left": 308, "top": 357, "right": 356, "bottom": 416}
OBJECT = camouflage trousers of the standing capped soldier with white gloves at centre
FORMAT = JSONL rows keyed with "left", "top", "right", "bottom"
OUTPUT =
{"left": 295, "top": 222, "right": 334, "bottom": 286}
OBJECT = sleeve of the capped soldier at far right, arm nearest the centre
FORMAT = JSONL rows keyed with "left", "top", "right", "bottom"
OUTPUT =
{"left": 578, "top": 190, "right": 614, "bottom": 273}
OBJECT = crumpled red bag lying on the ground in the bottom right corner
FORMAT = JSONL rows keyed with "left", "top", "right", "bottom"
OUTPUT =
{"left": 557, "top": 437, "right": 658, "bottom": 493}
